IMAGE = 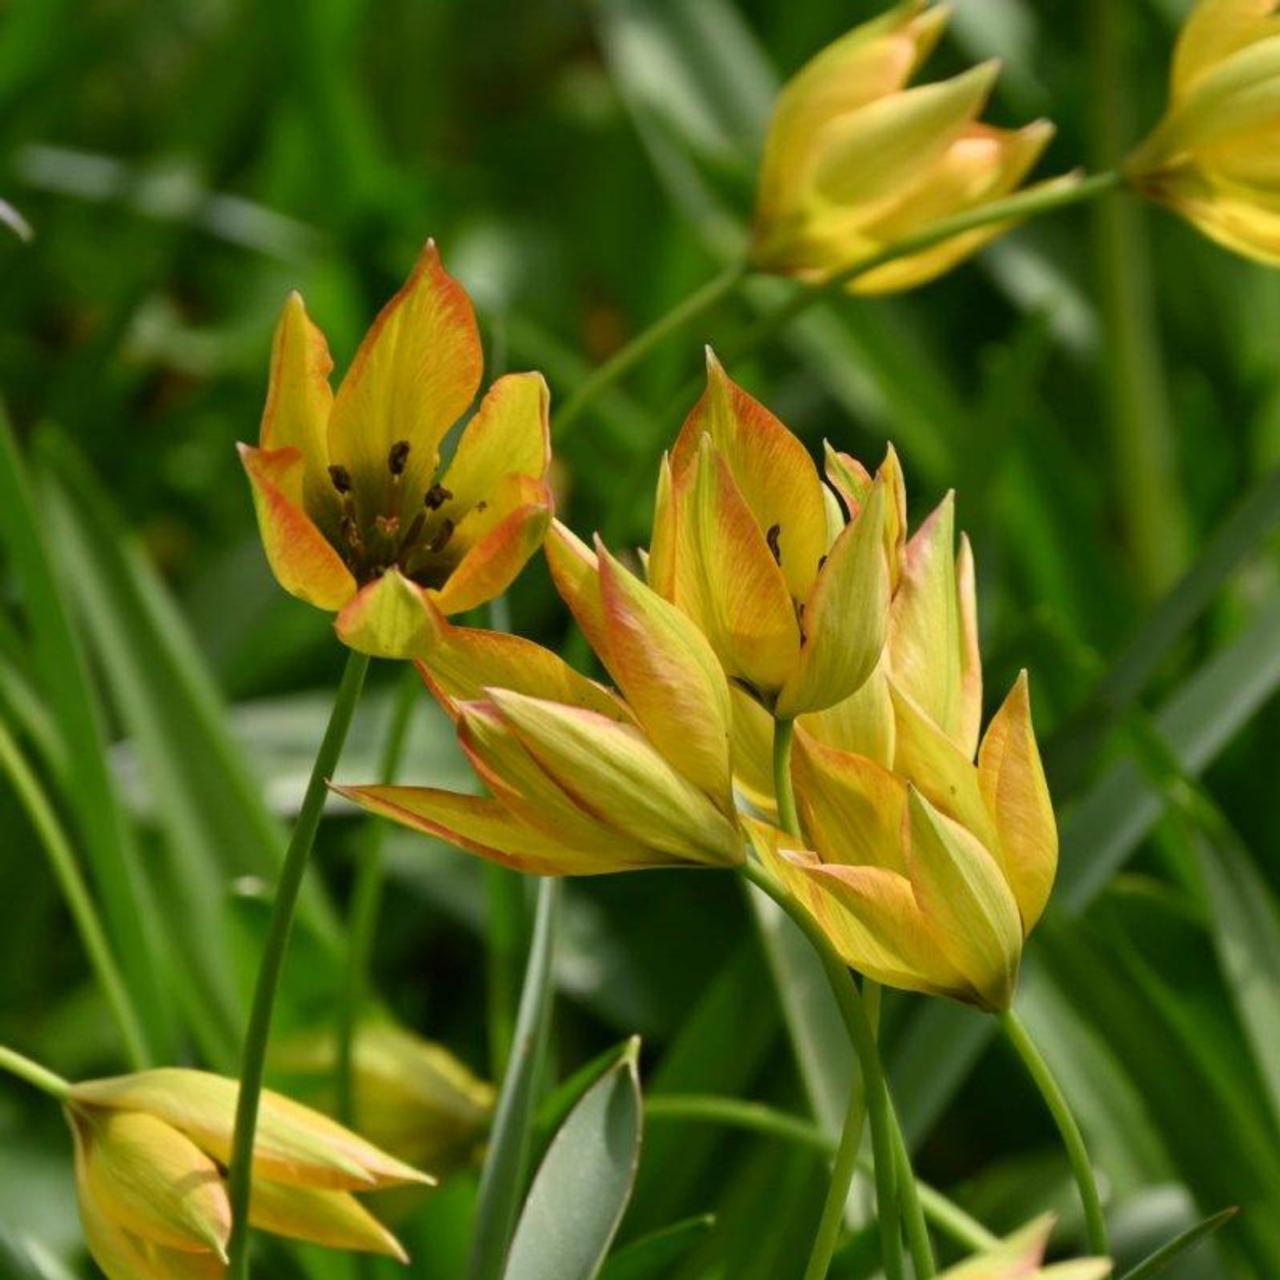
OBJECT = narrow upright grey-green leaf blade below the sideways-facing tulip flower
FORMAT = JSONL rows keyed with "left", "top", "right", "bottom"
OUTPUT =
{"left": 467, "top": 877, "right": 561, "bottom": 1280}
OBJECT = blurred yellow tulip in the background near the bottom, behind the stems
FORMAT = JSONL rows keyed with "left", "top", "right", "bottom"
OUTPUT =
{"left": 271, "top": 1019, "right": 494, "bottom": 1178}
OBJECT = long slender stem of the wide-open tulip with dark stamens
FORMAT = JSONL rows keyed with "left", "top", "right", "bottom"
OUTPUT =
{"left": 227, "top": 652, "right": 369, "bottom": 1280}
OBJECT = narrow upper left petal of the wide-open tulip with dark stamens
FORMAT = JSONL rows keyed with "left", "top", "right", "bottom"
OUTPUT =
{"left": 259, "top": 292, "right": 337, "bottom": 520}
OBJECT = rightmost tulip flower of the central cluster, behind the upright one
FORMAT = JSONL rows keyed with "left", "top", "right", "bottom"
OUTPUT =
{"left": 736, "top": 440, "right": 1057, "bottom": 1009}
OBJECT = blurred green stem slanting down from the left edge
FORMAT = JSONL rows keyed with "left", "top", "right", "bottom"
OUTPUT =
{"left": 0, "top": 723, "right": 148, "bottom": 1071}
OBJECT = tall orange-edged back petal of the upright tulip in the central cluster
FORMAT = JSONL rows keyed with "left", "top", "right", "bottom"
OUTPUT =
{"left": 671, "top": 348, "right": 827, "bottom": 600}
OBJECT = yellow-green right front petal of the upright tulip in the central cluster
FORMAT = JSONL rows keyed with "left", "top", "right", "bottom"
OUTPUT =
{"left": 777, "top": 468, "right": 890, "bottom": 718}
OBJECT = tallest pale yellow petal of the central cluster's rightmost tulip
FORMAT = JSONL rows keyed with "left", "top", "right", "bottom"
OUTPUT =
{"left": 888, "top": 494, "right": 969, "bottom": 744}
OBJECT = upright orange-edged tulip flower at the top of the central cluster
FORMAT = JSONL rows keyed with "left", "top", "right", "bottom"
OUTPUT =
{"left": 649, "top": 352, "right": 890, "bottom": 718}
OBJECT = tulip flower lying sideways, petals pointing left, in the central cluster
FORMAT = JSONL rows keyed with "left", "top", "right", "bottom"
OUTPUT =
{"left": 335, "top": 565, "right": 744, "bottom": 876}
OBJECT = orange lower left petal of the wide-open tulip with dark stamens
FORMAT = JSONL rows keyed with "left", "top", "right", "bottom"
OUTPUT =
{"left": 239, "top": 444, "right": 356, "bottom": 612}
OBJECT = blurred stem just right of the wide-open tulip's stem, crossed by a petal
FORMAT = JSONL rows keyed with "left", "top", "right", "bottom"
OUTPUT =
{"left": 335, "top": 666, "right": 422, "bottom": 1125}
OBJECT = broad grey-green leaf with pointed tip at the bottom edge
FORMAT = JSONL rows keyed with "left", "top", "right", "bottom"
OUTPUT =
{"left": 503, "top": 1039, "right": 644, "bottom": 1280}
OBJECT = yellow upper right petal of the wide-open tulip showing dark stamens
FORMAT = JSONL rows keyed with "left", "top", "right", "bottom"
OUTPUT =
{"left": 440, "top": 374, "right": 552, "bottom": 515}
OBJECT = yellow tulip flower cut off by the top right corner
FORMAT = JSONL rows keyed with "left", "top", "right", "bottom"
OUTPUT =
{"left": 1125, "top": 0, "right": 1280, "bottom": 265}
